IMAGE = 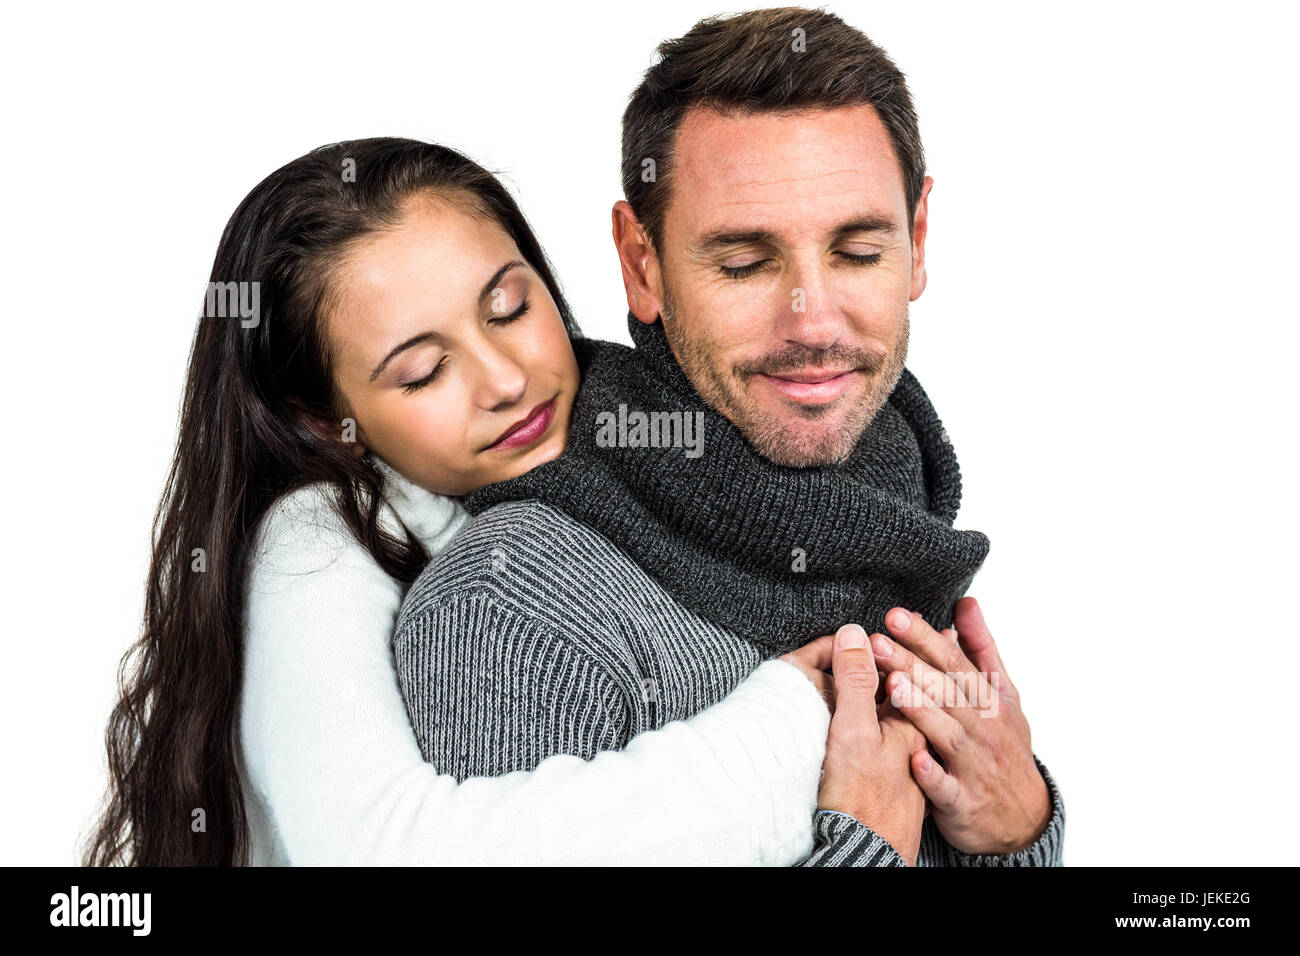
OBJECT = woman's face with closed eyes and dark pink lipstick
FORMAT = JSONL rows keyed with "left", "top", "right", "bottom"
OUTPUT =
{"left": 325, "top": 195, "right": 579, "bottom": 496}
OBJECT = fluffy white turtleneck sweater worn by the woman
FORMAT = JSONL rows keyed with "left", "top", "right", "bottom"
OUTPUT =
{"left": 239, "top": 462, "right": 829, "bottom": 865}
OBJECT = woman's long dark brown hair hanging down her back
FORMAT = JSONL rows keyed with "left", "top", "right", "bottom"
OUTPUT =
{"left": 83, "top": 138, "right": 580, "bottom": 866}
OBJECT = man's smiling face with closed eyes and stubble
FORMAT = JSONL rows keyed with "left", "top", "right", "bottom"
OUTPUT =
{"left": 634, "top": 105, "right": 931, "bottom": 467}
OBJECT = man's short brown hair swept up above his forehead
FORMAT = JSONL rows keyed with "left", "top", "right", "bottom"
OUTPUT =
{"left": 623, "top": 7, "right": 926, "bottom": 250}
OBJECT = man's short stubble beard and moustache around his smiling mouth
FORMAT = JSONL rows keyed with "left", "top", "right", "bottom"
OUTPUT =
{"left": 659, "top": 282, "right": 909, "bottom": 468}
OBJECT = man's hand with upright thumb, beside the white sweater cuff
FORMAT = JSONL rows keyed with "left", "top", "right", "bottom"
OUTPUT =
{"left": 784, "top": 624, "right": 926, "bottom": 866}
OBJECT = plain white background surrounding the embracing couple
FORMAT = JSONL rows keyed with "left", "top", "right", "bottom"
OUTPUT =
{"left": 0, "top": 0, "right": 1300, "bottom": 865}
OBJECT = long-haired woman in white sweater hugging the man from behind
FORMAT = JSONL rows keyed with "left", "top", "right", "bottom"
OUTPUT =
{"left": 85, "top": 139, "right": 829, "bottom": 865}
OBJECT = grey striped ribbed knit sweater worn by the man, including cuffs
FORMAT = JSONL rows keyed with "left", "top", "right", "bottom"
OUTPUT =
{"left": 393, "top": 501, "right": 1065, "bottom": 866}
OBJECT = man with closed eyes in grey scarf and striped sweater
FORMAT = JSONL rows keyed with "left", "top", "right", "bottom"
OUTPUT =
{"left": 394, "top": 8, "right": 1065, "bottom": 865}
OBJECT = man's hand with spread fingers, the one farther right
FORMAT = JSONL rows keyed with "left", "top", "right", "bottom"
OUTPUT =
{"left": 868, "top": 597, "right": 1052, "bottom": 853}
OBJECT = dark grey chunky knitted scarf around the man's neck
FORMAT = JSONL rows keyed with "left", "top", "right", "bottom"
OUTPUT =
{"left": 464, "top": 315, "right": 988, "bottom": 653}
